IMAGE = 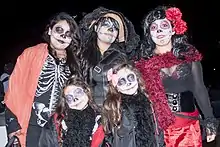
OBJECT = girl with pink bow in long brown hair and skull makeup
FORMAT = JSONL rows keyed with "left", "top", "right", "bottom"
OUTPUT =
{"left": 102, "top": 63, "right": 158, "bottom": 147}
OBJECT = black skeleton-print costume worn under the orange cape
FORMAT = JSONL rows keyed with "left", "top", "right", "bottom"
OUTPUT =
{"left": 6, "top": 45, "right": 70, "bottom": 146}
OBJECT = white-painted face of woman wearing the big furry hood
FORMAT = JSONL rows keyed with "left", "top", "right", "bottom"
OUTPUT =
{"left": 95, "top": 17, "right": 119, "bottom": 44}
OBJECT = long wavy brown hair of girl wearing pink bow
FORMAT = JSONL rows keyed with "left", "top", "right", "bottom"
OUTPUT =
{"left": 102, "top": 63, "right": 146, "bottom": 134}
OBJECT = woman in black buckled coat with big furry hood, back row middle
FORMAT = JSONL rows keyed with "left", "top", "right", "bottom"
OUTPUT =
{"left": 80, "top": 7, "right": 139, "bottom": 106}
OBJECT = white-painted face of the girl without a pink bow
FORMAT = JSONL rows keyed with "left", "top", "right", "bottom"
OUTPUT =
{"left": 64, "top": 85, "right": 89, "bottom": 110}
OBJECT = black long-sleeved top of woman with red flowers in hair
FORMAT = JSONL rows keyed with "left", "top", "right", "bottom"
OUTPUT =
{"left": 161, "top": 62, "right": 217, "bottom": 133}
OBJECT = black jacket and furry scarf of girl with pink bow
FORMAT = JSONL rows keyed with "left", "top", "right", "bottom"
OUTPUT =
{"left": 106, "top": 92, "right": 159, "bottom": 147}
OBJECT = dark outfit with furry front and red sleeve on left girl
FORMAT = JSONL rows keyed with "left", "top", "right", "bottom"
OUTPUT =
{"left": 39, "top": 107, "right": 104, "bottom": 147}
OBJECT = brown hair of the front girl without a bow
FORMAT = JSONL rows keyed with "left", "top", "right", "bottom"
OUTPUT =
{"left": 56, "top": 75, "right": 100, "bottom": 120}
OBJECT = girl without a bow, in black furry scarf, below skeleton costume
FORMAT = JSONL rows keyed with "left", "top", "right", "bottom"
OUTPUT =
{"left": 39, "top": 76, "right": 104, "bottom": 147}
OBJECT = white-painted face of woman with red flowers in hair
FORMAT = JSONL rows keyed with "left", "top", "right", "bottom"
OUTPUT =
{"left": 150, "top": 18, "right": 175, "bottom": 46}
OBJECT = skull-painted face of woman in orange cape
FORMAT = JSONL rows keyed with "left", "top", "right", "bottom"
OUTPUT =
{"left": 48, "top": 20, "right": 72, "bottom": 50}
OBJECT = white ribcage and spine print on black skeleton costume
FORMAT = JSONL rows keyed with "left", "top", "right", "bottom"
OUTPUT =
{"left": 35, "top": 55, "right": 70, "bottom": 115}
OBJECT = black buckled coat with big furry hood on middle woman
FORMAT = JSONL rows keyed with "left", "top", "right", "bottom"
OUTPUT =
{"left": 79, "top": 7, "right": 140, "bottom": 105}
